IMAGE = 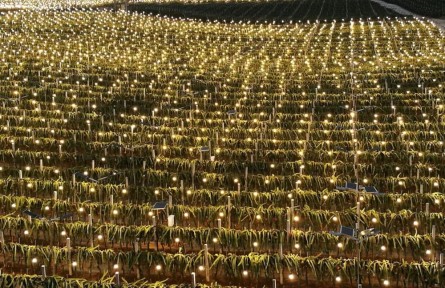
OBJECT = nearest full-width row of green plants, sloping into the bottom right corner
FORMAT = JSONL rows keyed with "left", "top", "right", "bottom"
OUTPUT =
{"left": 2, "top": 244, "right": 444, "bottom": 287}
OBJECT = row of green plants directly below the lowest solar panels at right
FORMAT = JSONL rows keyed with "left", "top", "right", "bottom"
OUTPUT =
{"left": 1, "top": 213, "right": 445, "bottom": 259}
